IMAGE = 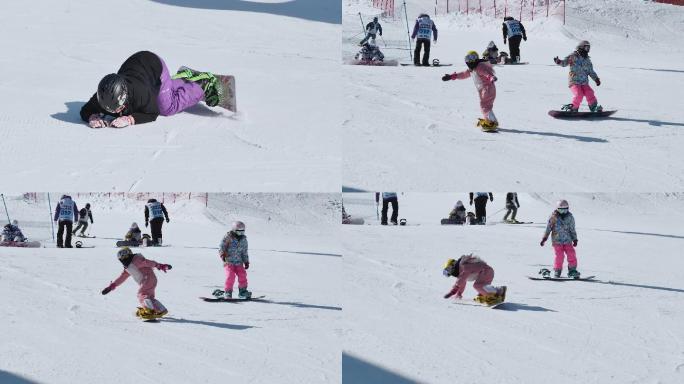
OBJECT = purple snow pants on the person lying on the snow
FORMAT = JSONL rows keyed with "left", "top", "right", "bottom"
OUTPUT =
{"left": 157, "top": 57, "right": 204, "bottom": 116}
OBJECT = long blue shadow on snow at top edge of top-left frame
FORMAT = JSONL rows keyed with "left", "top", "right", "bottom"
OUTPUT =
{"left": 152, "top": 0, "right": 342, "bottom": 24}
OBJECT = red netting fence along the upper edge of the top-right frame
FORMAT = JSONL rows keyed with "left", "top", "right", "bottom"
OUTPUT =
{"left": 435, "top": 0, "right": 565, "bottom": 24}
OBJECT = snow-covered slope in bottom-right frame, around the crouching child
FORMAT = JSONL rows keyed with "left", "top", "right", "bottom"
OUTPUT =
{"left": 343, "top": 192, "right": 684, "bottom": 383}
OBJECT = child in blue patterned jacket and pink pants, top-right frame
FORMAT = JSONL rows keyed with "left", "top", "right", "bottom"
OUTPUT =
{"left": 553, "top": 40, "right": 603, "bottom": 112}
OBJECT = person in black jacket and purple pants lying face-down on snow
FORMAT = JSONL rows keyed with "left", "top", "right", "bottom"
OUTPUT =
{"left": 81, "top": 51, "right": 220, "bottom": 128}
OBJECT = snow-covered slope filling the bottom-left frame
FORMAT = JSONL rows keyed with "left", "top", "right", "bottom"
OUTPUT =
{"left": 0, "top": 194, "right": 342, "bottom": 383}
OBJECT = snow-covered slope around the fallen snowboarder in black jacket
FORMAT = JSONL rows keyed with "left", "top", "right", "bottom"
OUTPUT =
{"left": 0, "top": 0, "right": 341, "bottom": 192}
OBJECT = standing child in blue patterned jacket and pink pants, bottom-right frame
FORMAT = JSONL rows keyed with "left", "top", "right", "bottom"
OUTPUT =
{"left": 539, "top": 200, "right": 580, "bottom": 279}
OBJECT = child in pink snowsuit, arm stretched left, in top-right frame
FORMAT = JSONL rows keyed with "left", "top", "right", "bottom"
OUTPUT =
{"left": 442, "top": 51, "right": 499, "bottom": 129}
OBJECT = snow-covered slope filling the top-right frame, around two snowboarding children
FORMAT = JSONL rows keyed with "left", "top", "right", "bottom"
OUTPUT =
{"left": 342, "top": 0, "right": 684, "bottom": 192}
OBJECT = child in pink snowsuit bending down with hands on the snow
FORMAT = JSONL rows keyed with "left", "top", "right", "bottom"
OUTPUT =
{"left": 442, "top": 254, "right": 506, "bottom": 305}
